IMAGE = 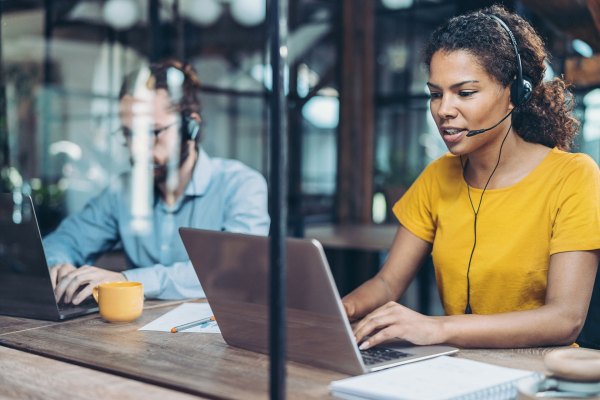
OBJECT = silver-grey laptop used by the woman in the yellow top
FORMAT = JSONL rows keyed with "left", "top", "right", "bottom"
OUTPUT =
{"left": 179, "top": 228, "right": 458, "bottom": 375}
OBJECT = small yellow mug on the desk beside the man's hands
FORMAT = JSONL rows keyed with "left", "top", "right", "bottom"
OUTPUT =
{"left": 92, "top": 282, "right": 144, "bottom": 322}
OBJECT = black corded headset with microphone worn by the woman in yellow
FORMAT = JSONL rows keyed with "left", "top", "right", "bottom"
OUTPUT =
{"left": 461, "top": 14, "right": 533, "bottom": 314}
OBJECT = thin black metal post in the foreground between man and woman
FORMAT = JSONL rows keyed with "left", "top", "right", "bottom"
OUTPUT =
{"left": 267, "top": 0, "right": 287, "bottom": 399}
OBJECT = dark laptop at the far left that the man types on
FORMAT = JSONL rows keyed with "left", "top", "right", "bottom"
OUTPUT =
{"left": 0, "top": 193, "right": 98, "bottom": 321}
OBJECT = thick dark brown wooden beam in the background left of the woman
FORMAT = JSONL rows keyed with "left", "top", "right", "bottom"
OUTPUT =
{"left": 336, "top": 0, "right": 375, "bottom": 223}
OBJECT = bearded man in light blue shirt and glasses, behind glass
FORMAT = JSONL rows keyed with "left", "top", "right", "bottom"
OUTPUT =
{"left": 44, "top": 61, "right": 270, "bottom": 304}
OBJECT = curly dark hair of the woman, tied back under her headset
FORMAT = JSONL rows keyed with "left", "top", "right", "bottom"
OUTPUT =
{"left": 424, "top": 5, "right": 579, "bottom": 150}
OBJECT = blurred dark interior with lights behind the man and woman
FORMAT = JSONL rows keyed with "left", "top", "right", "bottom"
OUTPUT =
{"left": 0, "top": 0, "right": 600, "bottom": 310}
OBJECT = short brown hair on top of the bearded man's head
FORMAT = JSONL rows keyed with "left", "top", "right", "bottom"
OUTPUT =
{"left": 119, "top": 59, "right": 202, "bottom": 114}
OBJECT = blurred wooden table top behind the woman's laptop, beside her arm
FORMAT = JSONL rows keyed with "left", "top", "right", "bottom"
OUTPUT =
{"left": 304, "top": 224, "right": 399, "bottom": 251}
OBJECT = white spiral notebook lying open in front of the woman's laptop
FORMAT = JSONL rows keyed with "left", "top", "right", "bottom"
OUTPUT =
{"left": 329, "top": 356, "right": 542, "bottom": 400}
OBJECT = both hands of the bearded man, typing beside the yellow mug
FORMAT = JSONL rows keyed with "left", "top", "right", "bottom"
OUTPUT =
{"left": 50, "top": 264, "right": 127, "bottom": 305}
